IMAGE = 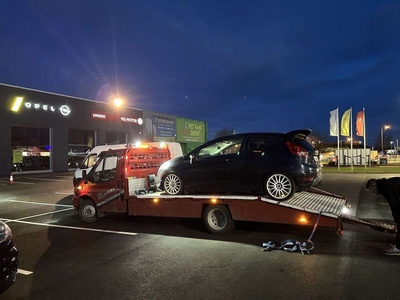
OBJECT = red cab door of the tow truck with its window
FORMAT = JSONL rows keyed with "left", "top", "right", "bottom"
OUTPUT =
{"left": 88, "top": 152, "right": 126, "bottom": 212}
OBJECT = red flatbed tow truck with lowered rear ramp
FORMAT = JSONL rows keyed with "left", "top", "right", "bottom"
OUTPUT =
{"left": 73, "top": 145, "right": 394, "bottom": 235}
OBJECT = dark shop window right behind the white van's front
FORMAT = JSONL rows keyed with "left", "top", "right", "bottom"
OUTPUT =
{"left": 68, "top": 128, "right": 96, "bottom": 169}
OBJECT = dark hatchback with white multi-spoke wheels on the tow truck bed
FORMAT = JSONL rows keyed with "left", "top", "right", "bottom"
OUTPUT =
{"left": 157, "top": 129, "right": 322, "bottom": 200}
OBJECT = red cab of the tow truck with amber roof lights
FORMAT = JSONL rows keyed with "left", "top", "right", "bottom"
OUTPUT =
{"left": 73, "top": 145, "right": 170, "bottom": 222}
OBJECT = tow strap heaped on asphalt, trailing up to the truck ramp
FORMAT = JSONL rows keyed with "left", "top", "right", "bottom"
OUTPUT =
{"left": 261, "top": 211, "right": 323, "bottom": 254}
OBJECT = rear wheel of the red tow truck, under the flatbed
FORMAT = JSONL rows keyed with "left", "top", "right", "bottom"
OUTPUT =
{"left": 203, "top": 205, "right": 235, "bottom": 234}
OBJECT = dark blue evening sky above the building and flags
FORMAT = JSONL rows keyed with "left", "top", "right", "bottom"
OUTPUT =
{"left": 0, "top": 0, "right": 400, "bottom": 144}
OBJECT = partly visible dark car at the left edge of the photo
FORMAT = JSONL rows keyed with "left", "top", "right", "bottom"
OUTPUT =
{"left": 0, "top": 221, "right": 18, "bottom": 294}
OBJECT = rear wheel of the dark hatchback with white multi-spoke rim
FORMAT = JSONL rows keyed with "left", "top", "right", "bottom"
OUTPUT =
{"left": 264, "top": 172, "right": 295, "bottom": 201}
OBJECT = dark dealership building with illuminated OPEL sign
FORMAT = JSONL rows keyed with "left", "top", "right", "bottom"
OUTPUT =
{"left": 0, "top": 84, "right": 207, "bottom": 175}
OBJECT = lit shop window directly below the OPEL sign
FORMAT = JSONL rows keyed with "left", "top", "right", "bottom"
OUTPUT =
{"left": 11, "top": 125, "right": 52, "bottom": 172}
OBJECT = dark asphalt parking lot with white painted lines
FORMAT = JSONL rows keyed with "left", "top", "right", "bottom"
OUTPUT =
{"left": 0, "top": 173, "right": 400, "bottom": 300}
